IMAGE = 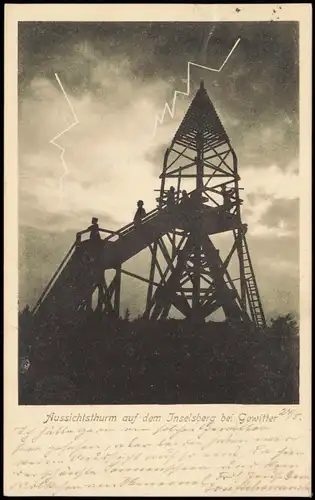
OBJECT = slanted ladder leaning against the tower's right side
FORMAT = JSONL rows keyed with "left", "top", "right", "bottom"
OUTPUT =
{"left": 242, "top": 234, "right": 266, "bottom": 328}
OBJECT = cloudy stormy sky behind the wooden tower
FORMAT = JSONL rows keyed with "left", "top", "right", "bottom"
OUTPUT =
{"left": 18, "top": 22, "right": 299, "bottom": 314}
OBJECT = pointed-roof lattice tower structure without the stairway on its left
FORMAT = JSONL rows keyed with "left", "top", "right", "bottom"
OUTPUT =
{"left": 145, "top": 82, "right": 265, "bottom": 327}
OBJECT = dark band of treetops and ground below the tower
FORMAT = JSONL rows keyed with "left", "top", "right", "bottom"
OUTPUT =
{"left": 19, "top": 309, "right": 299, "bottom": 404}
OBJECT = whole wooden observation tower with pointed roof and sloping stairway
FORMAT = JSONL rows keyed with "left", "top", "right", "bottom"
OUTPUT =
{"left": 33, "top": 82, "right": 266, "bottom": 329}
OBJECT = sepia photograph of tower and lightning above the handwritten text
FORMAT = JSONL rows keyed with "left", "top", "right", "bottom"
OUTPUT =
{"left": 16, "top": 18, "right": 302, "bottom": 405}
